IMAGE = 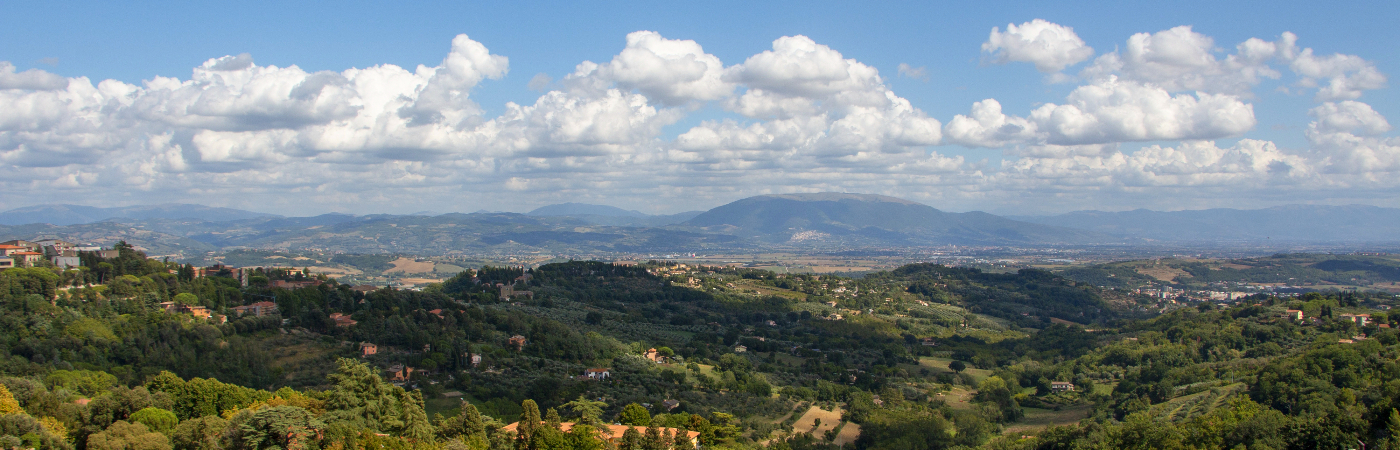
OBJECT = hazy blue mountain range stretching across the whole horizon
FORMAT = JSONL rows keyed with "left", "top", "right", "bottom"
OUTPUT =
{"left": 0, "top": 192, "right": 1400, "bottom": 257}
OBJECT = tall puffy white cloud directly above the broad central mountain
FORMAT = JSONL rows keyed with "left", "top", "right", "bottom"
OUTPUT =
{"left": 676, "top": 36, "right": 942, "bottom": 165}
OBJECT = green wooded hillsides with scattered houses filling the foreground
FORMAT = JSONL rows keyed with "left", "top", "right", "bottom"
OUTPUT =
{"left": 0, "top": 244, "right": 1400, "bottom": 450}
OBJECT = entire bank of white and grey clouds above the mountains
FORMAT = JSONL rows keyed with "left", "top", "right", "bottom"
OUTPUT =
{"left": 0, "top": 20, "right": 1400, "bottom": 214}
